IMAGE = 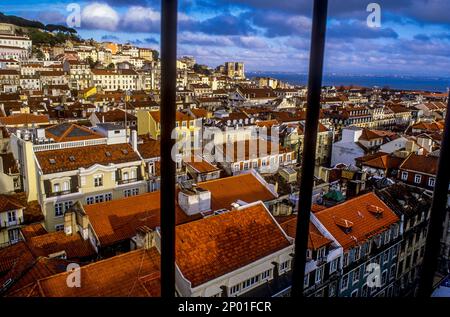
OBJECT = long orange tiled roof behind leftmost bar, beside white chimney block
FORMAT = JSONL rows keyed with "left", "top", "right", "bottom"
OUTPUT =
{"left": 83, "top": 174, "right": 275, "bottom": 246}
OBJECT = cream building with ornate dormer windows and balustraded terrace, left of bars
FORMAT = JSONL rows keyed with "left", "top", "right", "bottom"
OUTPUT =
{"left": 9, "top": 123, "right": 147, "bottom": 232}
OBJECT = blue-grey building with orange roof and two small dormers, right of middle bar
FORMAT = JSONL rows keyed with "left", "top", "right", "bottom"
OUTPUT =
{"left": 314, "top": 193, "right": 401, "bottom": 297}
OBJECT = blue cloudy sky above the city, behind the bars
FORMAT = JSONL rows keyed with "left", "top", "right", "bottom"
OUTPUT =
{"left": 0, "top": 0, "right": 450, "bottom": 77}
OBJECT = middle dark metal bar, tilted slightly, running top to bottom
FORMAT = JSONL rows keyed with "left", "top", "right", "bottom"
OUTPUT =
{"left": 292, "top": 0, "right": 328, "bottom": 297}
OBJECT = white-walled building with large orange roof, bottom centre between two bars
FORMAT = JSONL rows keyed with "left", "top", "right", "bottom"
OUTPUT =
{"left": 175, "top": 201, "right": 294, "bottom": 297}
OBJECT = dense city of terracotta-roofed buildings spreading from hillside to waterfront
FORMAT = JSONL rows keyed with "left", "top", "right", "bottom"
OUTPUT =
{"left": 0, "top": 0, "right": 450, "bottom": 298}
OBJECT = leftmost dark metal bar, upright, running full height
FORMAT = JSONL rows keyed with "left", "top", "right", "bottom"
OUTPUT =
{"left": 160, "top": 0, "right": 177, "bottom": 298}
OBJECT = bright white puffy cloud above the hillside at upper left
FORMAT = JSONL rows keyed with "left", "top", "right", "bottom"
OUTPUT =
{"left": 81, "top": 2, "right": 120, "bottom": 31}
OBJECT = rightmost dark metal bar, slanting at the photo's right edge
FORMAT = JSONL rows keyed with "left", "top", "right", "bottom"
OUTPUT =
{"left": 418, "top": 91, "right": 450, "bottom": 297}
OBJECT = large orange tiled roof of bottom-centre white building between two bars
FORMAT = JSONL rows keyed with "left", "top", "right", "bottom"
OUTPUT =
{"left": 176, "top": 202, "right": 291, "bottom": 287}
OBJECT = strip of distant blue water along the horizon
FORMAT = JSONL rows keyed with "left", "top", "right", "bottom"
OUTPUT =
{"left": 246, "top": 72, "right": 450, "bottom": 92}
